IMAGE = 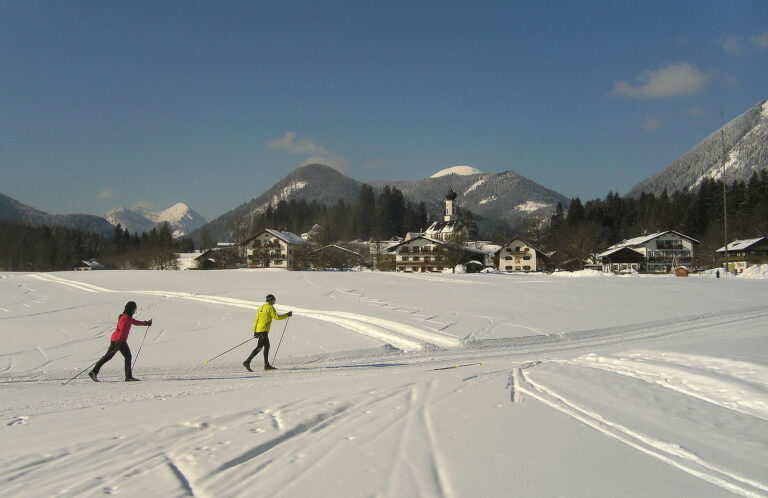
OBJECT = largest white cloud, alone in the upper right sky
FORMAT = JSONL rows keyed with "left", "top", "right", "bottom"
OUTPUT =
{"left": 613, "top": 62, "right": 708, "bottom": 99}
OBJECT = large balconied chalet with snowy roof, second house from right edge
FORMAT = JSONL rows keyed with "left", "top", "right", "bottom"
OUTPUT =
{"left": 603, "top": 230, "right": 699, "bottom": 273}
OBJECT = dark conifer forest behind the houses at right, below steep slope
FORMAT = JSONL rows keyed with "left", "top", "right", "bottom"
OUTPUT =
{"left": 544, "top": 170, "right": 768, "bottom": 265}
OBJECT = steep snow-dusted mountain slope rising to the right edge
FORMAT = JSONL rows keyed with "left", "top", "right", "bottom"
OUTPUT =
{"left": 628, "top": 100, "right": 768, "bottom": 197}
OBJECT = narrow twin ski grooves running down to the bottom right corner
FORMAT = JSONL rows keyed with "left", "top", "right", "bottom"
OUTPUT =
{"left": 508, "top": 362, "right": 768, "bottom": 497}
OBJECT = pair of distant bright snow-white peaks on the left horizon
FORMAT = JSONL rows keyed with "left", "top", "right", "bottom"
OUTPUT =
{"left": 106, "top": 202, "right": 207, "bottom": 237}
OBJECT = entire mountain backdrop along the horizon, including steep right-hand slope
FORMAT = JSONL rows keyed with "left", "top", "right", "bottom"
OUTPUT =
{"left": 0, "top": 101, "right": 768, "bottom": 241}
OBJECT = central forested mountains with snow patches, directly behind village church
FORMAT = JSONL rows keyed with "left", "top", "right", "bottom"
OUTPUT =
{"left": 198, "top": 164, "right": 569, "bottom": 240}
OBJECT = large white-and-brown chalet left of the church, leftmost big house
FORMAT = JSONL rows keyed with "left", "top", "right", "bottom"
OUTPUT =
{"left": 241, "top": 228, "right": 310, "bottom": 270}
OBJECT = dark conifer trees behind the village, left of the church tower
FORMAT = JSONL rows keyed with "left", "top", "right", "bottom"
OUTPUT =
{"left": 222, "top": 184, "right": 476, "bottom": 248}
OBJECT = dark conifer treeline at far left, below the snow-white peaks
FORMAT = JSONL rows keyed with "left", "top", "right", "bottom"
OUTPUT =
{"left": 0, "top": 220, "right": 192, "bottom": 271}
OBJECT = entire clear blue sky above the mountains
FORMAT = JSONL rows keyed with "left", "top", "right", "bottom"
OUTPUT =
{"left": 0, "top": 0, "right": 768, "bottom": 219}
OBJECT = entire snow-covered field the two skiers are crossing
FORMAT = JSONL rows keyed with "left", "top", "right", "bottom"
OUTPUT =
{"left": 0, "top": 270, "right": 768, "bottom": 497}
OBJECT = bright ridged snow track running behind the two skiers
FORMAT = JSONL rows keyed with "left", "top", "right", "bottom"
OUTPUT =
{"left": 29, "top": 273, "right": 461, "bottom": 352}
